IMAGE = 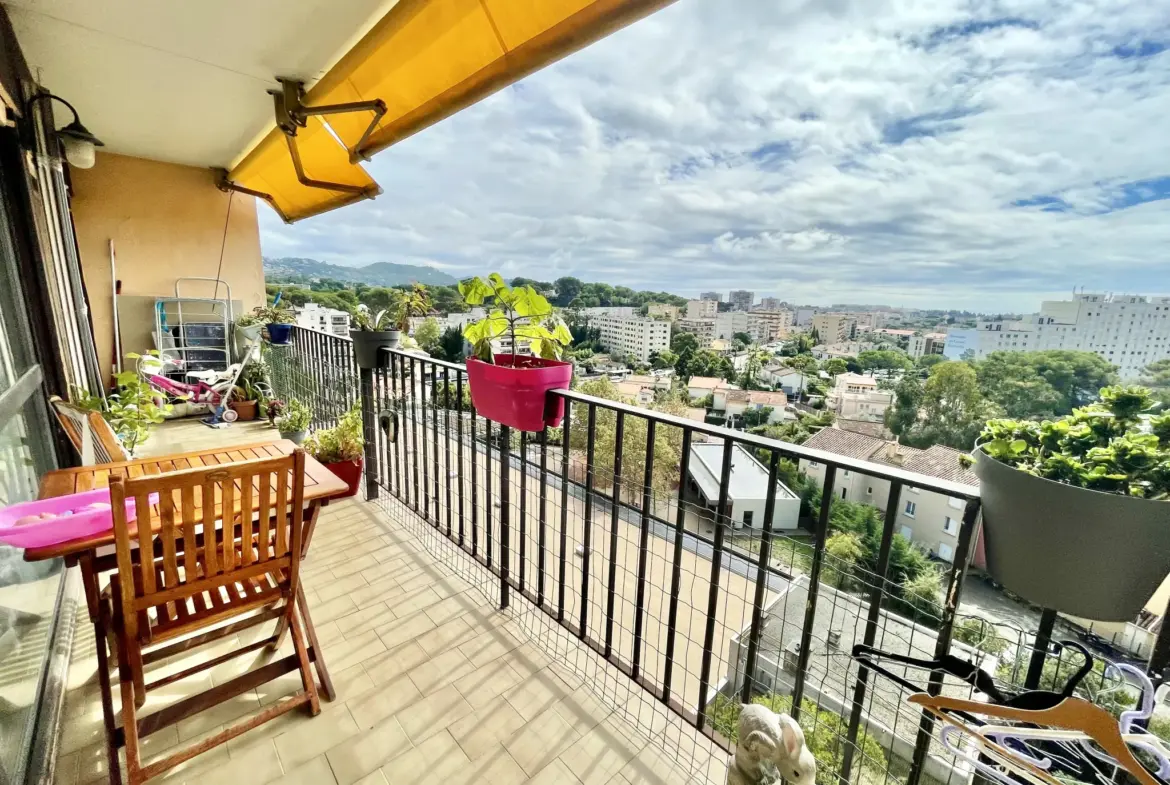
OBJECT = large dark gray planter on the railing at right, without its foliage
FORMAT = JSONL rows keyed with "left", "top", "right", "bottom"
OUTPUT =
{"left": 975, "top": 449, "right": 1170, "bottom": 621}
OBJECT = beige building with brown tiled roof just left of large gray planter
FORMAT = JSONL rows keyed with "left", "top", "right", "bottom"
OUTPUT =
{"left": 800, "top": 426, "right": 979, "bottom": 562}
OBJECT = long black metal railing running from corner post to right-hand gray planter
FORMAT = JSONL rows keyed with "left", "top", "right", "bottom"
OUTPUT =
{"left": 363, "top": 351, "right": 1024, "bottom": 785}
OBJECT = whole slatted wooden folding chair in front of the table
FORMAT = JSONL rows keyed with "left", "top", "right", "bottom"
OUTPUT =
{"left": 103, "top": 449, "right": 321, "bottom": 785}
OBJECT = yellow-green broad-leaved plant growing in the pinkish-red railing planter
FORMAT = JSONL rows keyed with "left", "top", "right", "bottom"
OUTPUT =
{"left": 459, "top": 273, "right": 573, "bottom": 367}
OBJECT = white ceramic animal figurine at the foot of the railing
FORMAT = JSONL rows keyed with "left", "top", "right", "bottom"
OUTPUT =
{"left": 728, "top": 703, "right": 817, "bottom": 785}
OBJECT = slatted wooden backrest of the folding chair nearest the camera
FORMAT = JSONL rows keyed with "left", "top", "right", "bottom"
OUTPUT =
{"left": 110, "top": 449, "right": 304, "bottom": 636}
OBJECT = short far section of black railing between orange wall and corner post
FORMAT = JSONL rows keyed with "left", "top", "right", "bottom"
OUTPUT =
{"left": 264, "top": 325, "right": 360, "bottom": 429}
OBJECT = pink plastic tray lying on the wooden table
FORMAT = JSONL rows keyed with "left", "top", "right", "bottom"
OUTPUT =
{"left": 0, "top": 488, "right": 158, "bottom": 548}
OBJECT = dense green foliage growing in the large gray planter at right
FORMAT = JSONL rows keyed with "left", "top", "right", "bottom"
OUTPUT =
{"left": 977, "top": 386, "right": 1170, "bottom": 500}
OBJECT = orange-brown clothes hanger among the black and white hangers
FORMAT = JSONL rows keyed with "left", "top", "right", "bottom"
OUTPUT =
{"left": 907, "top": 693, "right": 1159, "bottom": 785}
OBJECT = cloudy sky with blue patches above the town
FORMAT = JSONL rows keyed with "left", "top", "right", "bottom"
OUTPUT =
{"left": 260, "top": 0, "right": 1170, "bottom": 312}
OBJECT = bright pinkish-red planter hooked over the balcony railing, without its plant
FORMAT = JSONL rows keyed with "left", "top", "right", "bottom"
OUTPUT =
{"left": 467, "top": 354, "right": 573, "bottom": 431}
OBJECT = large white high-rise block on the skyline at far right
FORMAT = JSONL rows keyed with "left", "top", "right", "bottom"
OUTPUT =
{"left": 944, "top": 294, "right": 1170, "bottom": 380}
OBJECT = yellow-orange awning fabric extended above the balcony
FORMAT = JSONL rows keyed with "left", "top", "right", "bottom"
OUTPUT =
{"left": 229, "top": 0, "right": 673, "bottom": 221}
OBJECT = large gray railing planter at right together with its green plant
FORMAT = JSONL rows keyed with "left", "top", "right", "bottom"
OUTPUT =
{"left": 975, "top": 387, "right": 1170, "bottom": 621}
